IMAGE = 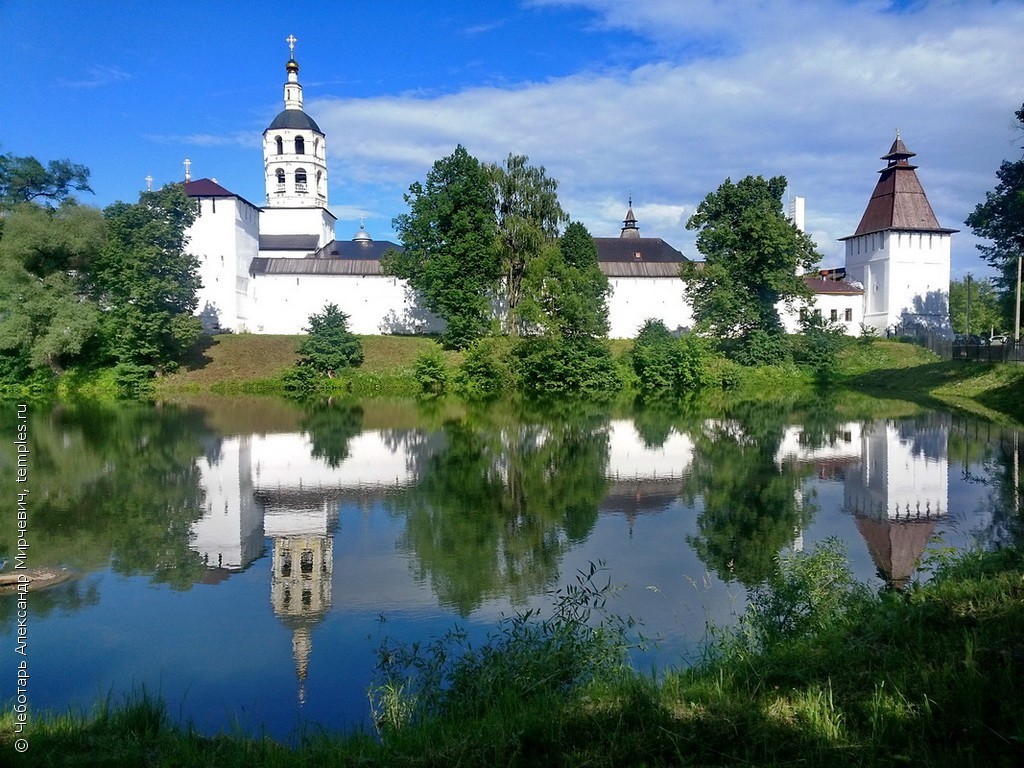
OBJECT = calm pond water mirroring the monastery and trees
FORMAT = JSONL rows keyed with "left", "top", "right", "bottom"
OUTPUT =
{"left": 0, "top": 400, "right": 1022, "bottom": 738}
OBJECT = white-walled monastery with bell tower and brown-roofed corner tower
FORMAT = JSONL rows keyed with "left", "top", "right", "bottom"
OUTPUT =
{"left": 185, "top": 37, "right": 956, "bottom": 338}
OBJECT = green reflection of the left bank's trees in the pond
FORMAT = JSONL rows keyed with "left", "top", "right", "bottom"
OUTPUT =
{"left": 2, "top": 406, "right": 206, "bottom": 589}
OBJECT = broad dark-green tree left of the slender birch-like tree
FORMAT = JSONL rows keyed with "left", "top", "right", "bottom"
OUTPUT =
{"left": 383, "top": 144, "right": 502, "bottom": 349}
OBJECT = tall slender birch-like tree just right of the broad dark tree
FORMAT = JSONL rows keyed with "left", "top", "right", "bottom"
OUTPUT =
{"left": 486, "top": 153, "right": 568, "bottom": 335}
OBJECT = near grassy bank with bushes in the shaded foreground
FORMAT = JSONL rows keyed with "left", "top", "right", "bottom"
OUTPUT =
{"left": 6, "top": 546, "right": 1024, "bottom": 768}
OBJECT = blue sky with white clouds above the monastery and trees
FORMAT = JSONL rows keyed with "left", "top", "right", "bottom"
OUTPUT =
{"left": 0, "top": 0, "right": 1024, "bottom": 279}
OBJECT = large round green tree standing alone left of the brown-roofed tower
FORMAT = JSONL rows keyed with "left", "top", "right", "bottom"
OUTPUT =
{"left": 683, "top": 176, "right": 821, "bottom": 361}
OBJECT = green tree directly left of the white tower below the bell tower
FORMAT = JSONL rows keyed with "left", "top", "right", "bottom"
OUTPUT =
{"left": 90, "top": 184, "right": 202, "bottom": 371}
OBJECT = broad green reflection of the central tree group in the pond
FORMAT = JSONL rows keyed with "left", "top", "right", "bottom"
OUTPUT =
{"left": 396, "top": 416, "right": 608, "bottom": 615}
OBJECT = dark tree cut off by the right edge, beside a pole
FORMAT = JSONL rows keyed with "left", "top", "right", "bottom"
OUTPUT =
{"left": 950, "top": 104, "right": 1024, "bottom": 328}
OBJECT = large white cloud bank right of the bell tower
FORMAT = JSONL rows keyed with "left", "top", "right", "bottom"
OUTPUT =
{"left": 307, "top": 0, "right": 1024, "bottom": 274}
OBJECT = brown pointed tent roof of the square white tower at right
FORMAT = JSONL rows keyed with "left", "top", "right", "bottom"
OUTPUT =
{"left": 840, "top": 136, "right": 957, "bottom": 240}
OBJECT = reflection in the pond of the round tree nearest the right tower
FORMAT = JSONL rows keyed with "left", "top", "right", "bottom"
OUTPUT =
{"left": 682, "top": 403, "right": 814, "bottom": 587}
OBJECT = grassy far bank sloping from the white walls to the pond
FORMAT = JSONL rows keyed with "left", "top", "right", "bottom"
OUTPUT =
{"left": 148, "top": 334, "right": 1024, "bottom": 423}
